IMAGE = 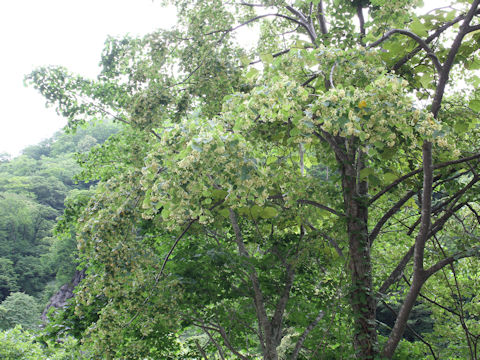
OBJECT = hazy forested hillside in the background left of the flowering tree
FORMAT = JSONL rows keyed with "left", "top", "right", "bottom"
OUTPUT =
{"left": 0, "top": 123, "right": 119, "bottom": 329}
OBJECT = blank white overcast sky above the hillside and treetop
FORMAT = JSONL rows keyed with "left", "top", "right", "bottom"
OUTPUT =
{"left": 0, "top": 0, "right": 445, "bottom": 156}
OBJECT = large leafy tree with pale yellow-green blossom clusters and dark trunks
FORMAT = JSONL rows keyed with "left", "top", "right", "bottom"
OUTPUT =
{"left": 28, "top": 0, "right": 480, "bottom": 360}
